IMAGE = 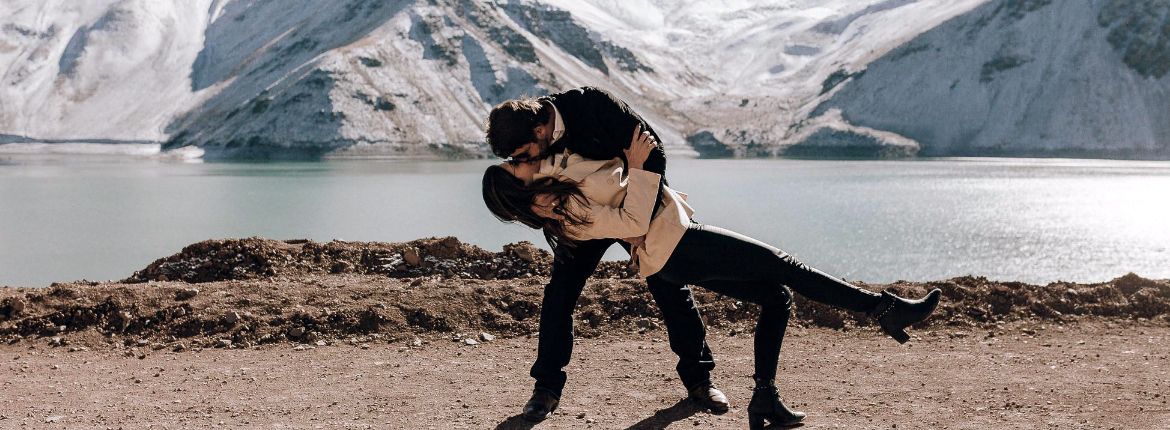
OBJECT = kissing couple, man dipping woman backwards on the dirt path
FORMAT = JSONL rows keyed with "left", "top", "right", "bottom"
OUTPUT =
{"left": 483, "top": 86, "right": 941, "bottom": 429}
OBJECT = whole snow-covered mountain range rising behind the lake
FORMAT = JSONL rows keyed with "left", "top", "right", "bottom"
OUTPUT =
{"left": 0, "top": 0, "right": 1170, "bottom": 158}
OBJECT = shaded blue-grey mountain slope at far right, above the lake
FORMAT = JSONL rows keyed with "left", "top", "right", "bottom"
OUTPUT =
{"left": 813, "top": 0, "right": 1170, "bottom": 159}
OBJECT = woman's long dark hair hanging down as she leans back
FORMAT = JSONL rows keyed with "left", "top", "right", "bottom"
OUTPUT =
{"left": 483, "top": 166, "right": 590, "bottom": 258}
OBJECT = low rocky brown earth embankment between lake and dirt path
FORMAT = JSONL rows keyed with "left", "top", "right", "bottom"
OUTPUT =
{"left": 0, "top": 237, "right": 1170, "bottom": 356}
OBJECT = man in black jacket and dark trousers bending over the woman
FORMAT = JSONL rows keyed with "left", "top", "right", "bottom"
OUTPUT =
{"left": 487, "top": 86, "right": 729, "bottom": 422}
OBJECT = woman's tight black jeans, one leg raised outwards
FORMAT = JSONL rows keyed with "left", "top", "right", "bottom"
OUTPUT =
{"left": 647, "top": 224, "right": 881, "bottom": 380}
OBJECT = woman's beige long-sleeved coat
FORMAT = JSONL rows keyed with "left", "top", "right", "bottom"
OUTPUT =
{"left": 537, "top": 151, "right": 695, "bottom": 277}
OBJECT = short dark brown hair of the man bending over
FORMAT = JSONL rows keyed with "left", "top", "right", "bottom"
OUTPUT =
{"left": 488, "top": 97, "right": 552, "bottom": 158}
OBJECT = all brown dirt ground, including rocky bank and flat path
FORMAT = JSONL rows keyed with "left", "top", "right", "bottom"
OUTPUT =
{"left": 0, "top": 238, "right": 1170, "bottom": 429}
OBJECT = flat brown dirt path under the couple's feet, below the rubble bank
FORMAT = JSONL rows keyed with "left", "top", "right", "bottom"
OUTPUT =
{"left": 0, "top": 320, "right": 1170, "bottom": 429}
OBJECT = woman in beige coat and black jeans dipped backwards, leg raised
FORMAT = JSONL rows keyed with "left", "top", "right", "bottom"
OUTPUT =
{"left": 483, "top": 130, "right": 941, "bottom": 429}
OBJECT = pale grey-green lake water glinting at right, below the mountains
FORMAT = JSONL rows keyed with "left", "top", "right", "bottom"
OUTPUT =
{"left": 0, "top": 154, "right": 1170, "bottom": 286}
